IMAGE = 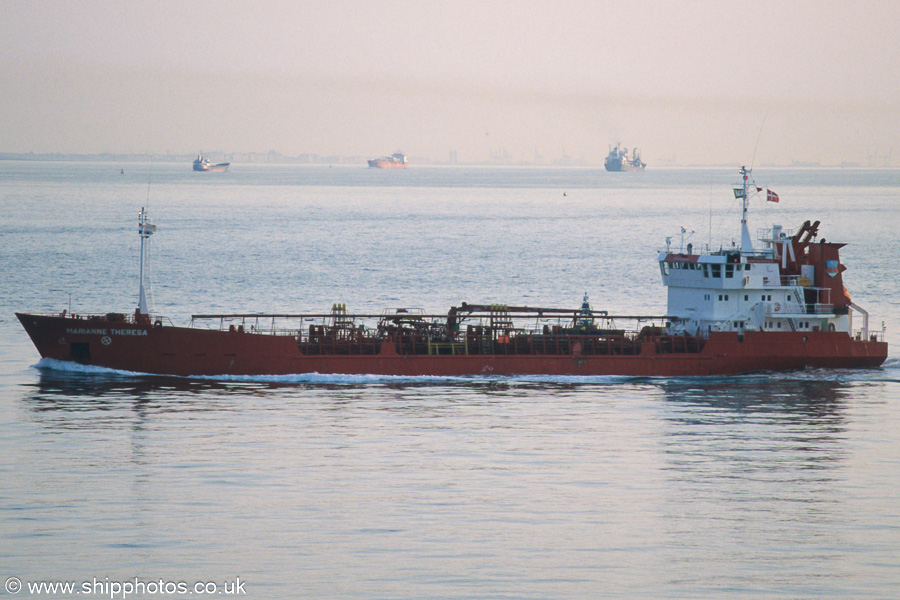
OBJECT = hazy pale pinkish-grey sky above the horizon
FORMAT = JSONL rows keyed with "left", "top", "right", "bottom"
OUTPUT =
{"left": 0, "top": 0, "right": 900, "bottom": 165}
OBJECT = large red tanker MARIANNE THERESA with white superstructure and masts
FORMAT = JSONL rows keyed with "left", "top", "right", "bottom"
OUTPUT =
{"left": 16, "top": 168, "right": 888, "bottom": 377}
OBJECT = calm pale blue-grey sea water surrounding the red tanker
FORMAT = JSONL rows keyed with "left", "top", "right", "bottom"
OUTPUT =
{"left": 0, "top": 162, "right": 900, "bottom": 599}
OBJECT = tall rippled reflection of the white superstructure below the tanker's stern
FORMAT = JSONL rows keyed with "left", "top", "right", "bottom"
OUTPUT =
{"left": 648, "top": 375, "right": 859, "bottom": 597}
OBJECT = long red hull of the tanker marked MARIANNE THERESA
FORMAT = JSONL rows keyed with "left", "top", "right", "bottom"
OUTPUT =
{"left": 16, "top": 313, "right": 887, "bottom": 377}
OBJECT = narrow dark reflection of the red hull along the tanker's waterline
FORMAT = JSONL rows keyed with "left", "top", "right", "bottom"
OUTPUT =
{"left": 23, "top": 368, "right": 864, "bottom": 416}
